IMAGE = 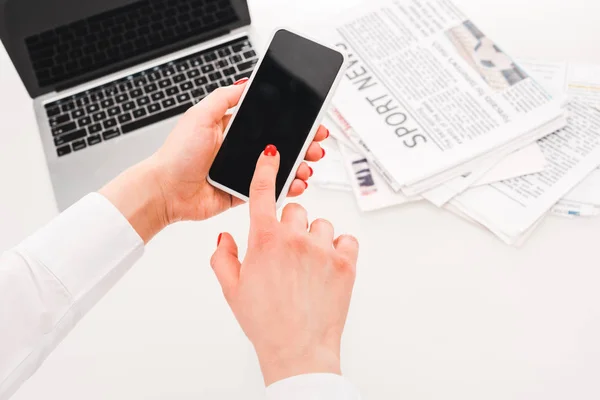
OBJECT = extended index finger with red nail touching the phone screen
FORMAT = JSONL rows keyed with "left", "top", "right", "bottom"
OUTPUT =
{"left": 250, "top": 144, "right": 279, "bottom": 224}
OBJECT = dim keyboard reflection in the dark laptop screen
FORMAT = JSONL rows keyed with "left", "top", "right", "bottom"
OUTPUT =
{"left": 25, "top": 0, "right": 238, "bottom": 87}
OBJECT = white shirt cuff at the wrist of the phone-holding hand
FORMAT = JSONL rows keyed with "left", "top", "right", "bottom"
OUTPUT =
{"left": 19, "top": 193, "right": 144, "bottom": 301}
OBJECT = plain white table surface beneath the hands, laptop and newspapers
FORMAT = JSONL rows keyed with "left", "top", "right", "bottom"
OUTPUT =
{"left": 0, "top": 0, "right": 600, "bottom": 400}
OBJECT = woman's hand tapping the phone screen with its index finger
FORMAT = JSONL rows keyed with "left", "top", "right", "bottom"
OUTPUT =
{"left": 211, "top": 145, "right": 358, "bottom": 386}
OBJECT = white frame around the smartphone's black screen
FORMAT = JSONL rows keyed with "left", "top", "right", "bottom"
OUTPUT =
{"left": 207, "top": 28, "right": 347, "bottom": 208}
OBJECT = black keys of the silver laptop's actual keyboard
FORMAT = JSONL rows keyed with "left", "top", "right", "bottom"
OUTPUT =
{"left": 45, "top": 38, "right": 258, "bottom": 157}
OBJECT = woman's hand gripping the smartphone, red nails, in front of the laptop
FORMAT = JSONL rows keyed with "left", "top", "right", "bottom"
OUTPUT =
{"left": 100, "top": 81, "right": 329, "bottom": 242}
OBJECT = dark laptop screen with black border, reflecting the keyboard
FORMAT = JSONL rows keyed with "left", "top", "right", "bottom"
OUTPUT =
{"left": 0, "top": 0, "right": 250, "bottom": 97}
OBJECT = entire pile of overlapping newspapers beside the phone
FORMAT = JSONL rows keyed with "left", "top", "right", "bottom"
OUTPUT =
{"left": 316, "top": 0, "right": 600, "bottom": 244}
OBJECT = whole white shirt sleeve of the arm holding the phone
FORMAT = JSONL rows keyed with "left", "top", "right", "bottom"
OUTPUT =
{"left": 0, "top": 193, "right": 144, "bottom": 400}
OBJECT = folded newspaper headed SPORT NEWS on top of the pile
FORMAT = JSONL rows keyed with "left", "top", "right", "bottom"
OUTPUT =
{"left": 328, "top": 0, "right": 562, "bottom": 195}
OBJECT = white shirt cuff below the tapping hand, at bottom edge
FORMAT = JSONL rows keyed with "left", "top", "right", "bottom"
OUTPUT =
{"left": 267, "top": 374, "right": 360, "bottom": 400}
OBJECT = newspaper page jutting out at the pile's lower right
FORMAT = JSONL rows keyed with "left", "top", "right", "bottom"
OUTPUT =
{"left": 451, "top": 100, "right": 600, "bottom": 244}
